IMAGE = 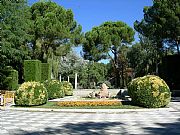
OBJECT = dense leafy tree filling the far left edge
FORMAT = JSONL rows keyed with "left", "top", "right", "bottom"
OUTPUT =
{"left": 0, "top": 0, "right": 32, "bottom": 83}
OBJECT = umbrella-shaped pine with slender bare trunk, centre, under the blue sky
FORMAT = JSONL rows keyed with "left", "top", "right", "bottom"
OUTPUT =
{"left": 83, "top": 21, "right": 134, "bottom": 87}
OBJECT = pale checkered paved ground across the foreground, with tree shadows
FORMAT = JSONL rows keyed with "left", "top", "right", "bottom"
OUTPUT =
{"left": 0, "top": 108, "right": 180, "bottom": 135}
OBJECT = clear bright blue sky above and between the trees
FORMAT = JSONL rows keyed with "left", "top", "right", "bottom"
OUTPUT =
{"left": 28, "top": 0, "right": 152, "bottom": 62}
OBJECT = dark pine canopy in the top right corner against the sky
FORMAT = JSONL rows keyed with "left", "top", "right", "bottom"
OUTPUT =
{"left": 134, "top": 0, "right": 180, "bottom": 54}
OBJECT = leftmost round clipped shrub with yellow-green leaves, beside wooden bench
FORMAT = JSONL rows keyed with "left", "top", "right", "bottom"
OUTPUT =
{"left": 15, "top": 82, "right": 47, "bottom": 106}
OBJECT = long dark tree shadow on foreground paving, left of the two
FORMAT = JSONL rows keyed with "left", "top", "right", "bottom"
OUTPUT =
{"left": 14, "top": 122, "right": 128, "bottom": 135}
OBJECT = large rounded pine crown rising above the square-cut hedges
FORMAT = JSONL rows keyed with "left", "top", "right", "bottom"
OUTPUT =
{"left": 30, "top": 1, "right": 82, "bottom": 61}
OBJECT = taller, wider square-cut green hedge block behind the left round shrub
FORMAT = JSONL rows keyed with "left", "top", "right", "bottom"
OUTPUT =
{"left": 24, "top": 60, "right": 41, "bottom": 82}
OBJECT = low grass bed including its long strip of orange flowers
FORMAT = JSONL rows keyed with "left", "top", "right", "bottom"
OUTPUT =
{"left": 14, "top": 100, "right": 142, "bottom": 109}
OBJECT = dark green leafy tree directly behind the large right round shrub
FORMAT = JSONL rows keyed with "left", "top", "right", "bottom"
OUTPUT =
{"left": 127, "top": 35, "right": 169, "bottom": 77}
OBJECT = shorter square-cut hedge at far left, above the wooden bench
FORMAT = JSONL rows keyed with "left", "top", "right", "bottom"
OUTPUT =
{"left": 6, "top": 70, "right": 18, "bottom": 90}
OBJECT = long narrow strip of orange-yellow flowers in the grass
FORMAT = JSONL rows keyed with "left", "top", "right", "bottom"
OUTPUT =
{"left": 57, "top": 100, "right": 122, "bottom": 107}
